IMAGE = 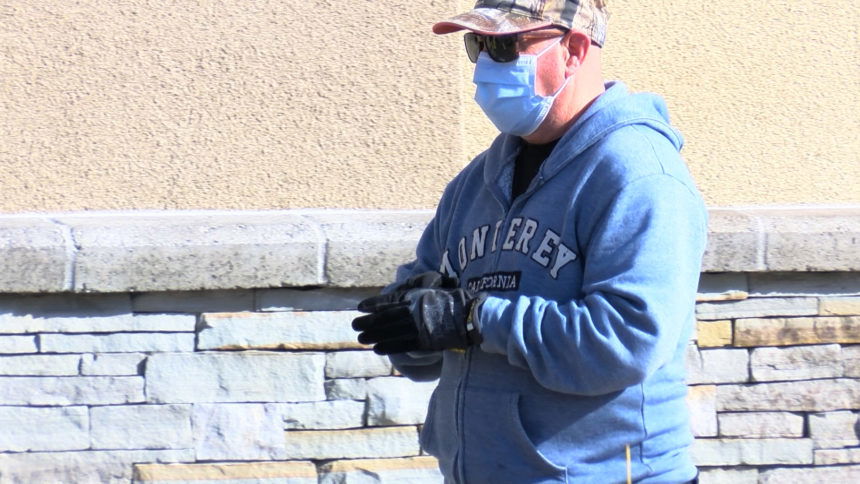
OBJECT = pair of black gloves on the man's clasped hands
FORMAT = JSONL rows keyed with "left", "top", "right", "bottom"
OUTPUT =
{"left": 352, "top": 287, "right": 483, "bottom": 355}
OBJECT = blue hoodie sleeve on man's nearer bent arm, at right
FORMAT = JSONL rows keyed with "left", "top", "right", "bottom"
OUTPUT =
{"left": 480, "top": 174, "right": 706, "bottom": 395}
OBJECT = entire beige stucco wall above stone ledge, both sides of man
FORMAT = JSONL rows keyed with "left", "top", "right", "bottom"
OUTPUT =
{"left": 0, "top": 0, "right": 860, "bottom": 212}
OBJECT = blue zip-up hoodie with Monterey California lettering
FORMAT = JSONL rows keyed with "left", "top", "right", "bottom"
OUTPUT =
{"left": 392, "top": 83, "right": 707, "bottom": 483}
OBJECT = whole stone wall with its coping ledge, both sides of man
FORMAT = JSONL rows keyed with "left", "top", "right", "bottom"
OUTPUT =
{"left": 0, "top": 208, "right": 860, "bottom": 484}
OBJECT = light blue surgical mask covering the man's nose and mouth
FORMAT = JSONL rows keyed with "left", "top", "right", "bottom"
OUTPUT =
{"left": 472, "top": 37, "right": 573, "bottom": 136}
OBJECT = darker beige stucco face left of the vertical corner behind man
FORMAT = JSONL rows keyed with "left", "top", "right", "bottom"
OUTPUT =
{"left": 0, "top": 0, "right": 460, "bottom": 212}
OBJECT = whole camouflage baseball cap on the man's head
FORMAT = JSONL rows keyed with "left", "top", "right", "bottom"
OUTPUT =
{"left": 433, "top": 0, "right": 609, "bottom": 47}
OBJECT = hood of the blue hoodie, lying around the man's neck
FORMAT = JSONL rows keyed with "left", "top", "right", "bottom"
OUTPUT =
{"left": 484, "top": 81, "right": 684, "bottom": 190}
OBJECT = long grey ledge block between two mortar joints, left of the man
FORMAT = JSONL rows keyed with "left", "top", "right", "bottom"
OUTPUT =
{"left": 62, "top": 212, "right": 324, "bottom": 292}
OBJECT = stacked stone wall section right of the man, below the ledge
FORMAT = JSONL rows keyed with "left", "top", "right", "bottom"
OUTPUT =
{"left": 687, "top": 272, "right": 860, "bottom": 483}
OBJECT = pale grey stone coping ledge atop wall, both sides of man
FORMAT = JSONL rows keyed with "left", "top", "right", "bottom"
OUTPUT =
{"left": 0, "top": 205, "right": 860, "bottom": 293}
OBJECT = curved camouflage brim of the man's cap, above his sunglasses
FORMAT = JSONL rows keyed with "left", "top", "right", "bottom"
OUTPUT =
{"left": 433, "top": 8, "right": 552, "bottom": 35}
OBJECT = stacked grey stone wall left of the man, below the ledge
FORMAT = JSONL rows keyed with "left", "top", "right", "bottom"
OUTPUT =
{"left": 0, "top": 288, "right": 439, "bottom": 483}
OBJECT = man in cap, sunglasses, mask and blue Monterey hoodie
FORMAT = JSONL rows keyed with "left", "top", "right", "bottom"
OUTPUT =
{"left": 353, "top": 0, "right": 706, "bottom": 483}
